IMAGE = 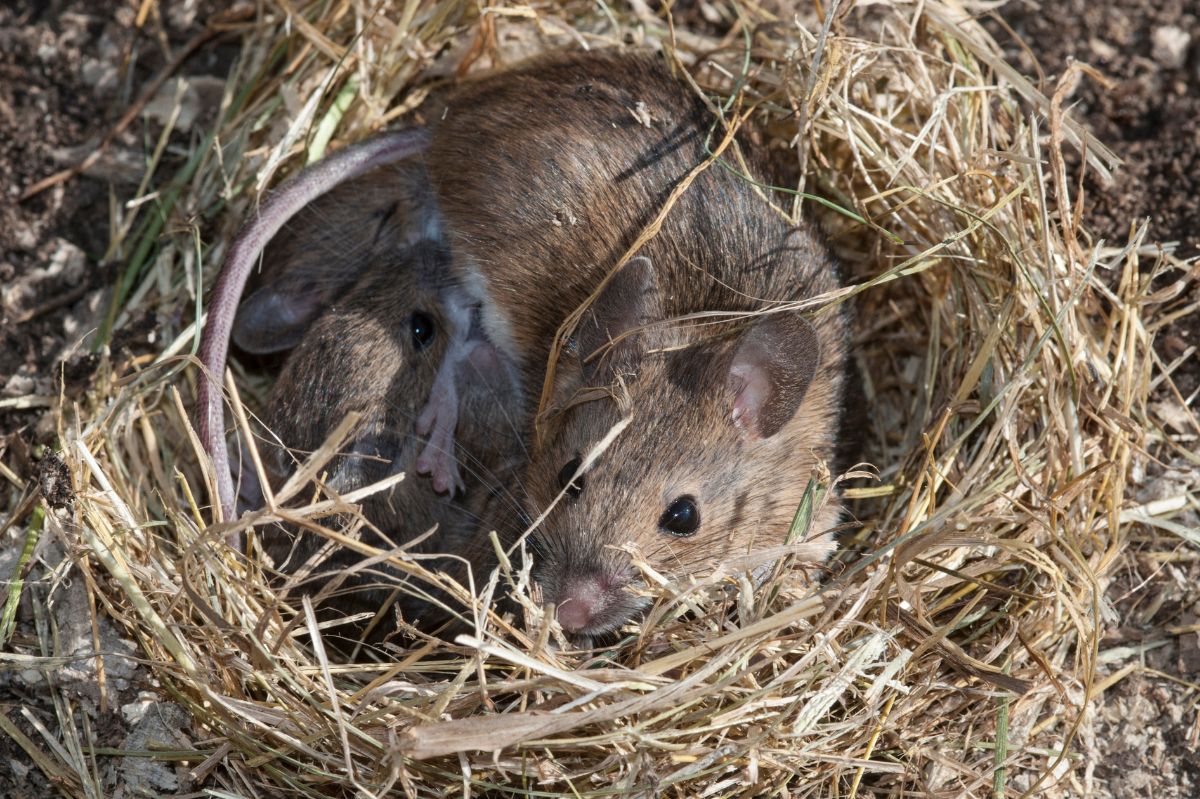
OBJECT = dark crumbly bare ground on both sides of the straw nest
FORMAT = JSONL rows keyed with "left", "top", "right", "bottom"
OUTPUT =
{"left": 0, "top": 0, "right": 1200, "bottom": 798}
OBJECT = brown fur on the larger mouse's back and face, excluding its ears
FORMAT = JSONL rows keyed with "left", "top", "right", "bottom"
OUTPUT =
{"left": 428, "top": 53, "right": 846, "bottom": 629}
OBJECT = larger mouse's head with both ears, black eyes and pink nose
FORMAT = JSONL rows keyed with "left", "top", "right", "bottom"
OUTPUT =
{"left": 522, "top": 258, "right": 838, "bottom": 636}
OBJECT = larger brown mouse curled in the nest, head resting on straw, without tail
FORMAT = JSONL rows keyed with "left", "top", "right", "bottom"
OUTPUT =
{"left": 425, "top": 52, "right": 847, "bottom": 636}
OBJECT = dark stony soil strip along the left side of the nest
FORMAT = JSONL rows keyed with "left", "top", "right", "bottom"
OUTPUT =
{"left": 0, "top": 0, "right": 235, "bottom": 798}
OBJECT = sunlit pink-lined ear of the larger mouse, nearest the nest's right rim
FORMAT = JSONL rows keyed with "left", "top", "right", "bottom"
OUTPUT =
{"left": 727, "top": 313, "right": 821, "bottom": 438}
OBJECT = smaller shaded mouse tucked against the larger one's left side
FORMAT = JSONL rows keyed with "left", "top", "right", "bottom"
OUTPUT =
{"left": 240, "top": 239, "right": 521, "bottom": 632}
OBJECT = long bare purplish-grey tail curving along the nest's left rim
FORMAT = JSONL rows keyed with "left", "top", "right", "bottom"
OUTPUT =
{"left": 197, "top": 128, "right": 428, "bottom": 521}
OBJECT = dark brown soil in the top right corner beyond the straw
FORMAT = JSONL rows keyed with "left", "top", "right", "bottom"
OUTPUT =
{"left": 1000, "top": 0, "right": 1200, "bottom": 258}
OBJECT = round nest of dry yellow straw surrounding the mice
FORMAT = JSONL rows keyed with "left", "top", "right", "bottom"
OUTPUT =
{"left": 11, "top": 0, "right": 1200, "bottom": 797}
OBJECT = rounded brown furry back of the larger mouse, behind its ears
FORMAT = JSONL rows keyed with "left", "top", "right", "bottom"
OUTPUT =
{"left": 428, "top": 52, "right": 836, "bottom": 382}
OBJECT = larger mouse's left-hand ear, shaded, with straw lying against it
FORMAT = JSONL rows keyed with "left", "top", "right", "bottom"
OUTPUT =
{"left": 575, "top": 258, "right": 662, "bottom": 385}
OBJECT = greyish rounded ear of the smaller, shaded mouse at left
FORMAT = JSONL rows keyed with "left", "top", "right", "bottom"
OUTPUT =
{"left": 232, "top": 278, "right": 328, "bottom": 355}
